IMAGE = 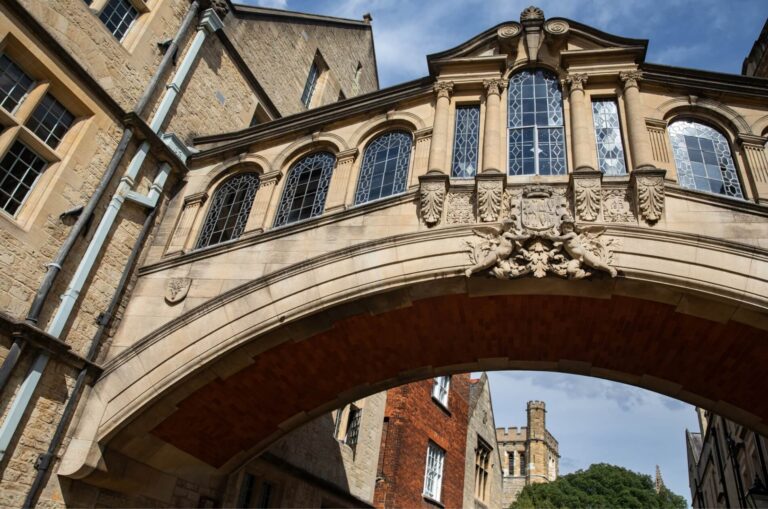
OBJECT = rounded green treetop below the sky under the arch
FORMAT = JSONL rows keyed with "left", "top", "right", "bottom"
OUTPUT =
{"left": 511, "top": 463, "right": 687, "bottom": 509}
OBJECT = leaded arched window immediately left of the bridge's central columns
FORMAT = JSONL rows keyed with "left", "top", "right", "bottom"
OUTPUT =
{"left": 355, "top": 131, "right": 411, "bottom": 204}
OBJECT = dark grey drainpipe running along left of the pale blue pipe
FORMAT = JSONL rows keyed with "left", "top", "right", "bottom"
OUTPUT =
{"left": 8, "top": 0, "right": 200, "bottom": 374}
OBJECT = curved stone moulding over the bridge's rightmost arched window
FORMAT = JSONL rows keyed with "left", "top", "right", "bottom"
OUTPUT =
{"left": 656, "top": 97, "right": 752, "bottom": 137}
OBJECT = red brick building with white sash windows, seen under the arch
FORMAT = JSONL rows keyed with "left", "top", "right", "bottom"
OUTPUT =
{"left": 374, "top": 374, "right": 470, "bottom": 508}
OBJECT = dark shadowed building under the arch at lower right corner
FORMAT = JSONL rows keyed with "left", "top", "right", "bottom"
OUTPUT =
{"left": 685, "top": 408, "right": 768, "bottom": 508}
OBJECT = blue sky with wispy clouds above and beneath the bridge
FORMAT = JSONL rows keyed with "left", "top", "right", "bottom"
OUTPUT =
{"left": 238, "top": 0, "right": 768, "bottom": 503}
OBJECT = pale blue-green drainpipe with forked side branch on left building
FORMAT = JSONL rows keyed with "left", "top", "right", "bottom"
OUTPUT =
{"left": 0, "top": 5, "right": 223, "bottom": 461}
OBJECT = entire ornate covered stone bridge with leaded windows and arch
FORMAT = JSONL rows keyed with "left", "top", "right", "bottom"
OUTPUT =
{"left": 59, "top": 10, "right": 768, "bottom": 496}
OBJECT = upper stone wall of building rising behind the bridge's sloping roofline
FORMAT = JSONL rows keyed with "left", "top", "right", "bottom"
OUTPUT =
{"left": 225, "top": 15, "right": 378, "bottom": 116}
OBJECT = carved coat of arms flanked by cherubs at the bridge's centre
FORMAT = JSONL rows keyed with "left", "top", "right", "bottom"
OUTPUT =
{"left": 465, "top": 186, "right": 617, "bottom": 279}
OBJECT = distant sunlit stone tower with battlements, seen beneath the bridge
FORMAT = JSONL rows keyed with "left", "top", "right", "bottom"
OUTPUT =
{"left": 496, "top": 401, "right": 560, "bottom": 507}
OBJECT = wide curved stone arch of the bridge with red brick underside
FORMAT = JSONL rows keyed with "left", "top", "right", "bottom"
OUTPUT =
{"left": 60, "top": 225, "right": 768, "bottom": 477}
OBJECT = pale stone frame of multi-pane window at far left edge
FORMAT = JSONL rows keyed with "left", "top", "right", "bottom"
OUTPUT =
{"left": 0, "top": 33, "right": 93, "bottom": 227}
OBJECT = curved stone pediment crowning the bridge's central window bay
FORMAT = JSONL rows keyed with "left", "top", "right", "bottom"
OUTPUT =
{"left": 427, "top": 7, "right": 648, "bottom": 76}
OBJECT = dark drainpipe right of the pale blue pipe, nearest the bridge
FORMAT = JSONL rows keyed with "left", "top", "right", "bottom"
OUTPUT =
{"left": 22, "top": 207, "right": 157, "bottom": 508}
